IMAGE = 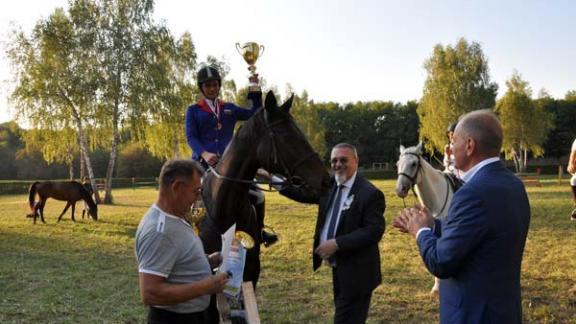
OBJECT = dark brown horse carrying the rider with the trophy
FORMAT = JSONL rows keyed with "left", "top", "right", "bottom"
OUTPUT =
{"left": 200, "top": 92, "right": 330, "bottom": 285}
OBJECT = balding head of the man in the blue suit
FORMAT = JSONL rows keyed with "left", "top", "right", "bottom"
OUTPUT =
{"left": 456, "top": 109, "right": 503, "bottom": 157}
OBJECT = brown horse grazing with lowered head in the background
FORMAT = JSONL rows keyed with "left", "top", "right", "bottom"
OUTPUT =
{"left": 28, "top": 181, "right": 98, "bottom": 224}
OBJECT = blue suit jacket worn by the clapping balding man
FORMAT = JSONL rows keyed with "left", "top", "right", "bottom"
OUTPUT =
{"left": 417, "top": 162, "right": 530, "bottom": 324}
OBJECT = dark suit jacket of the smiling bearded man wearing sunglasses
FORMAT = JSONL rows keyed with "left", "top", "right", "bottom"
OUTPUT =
{"left": 281, "top": 174, "right": 386, "bottom": 297}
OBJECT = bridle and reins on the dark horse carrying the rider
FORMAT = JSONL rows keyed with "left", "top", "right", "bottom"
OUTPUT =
{"left": 209, "top": 111, "right": 320, "bottom": 191}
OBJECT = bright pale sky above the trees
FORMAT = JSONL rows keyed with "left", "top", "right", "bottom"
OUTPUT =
{"left": 0, "top": 0, "right": 576, "bottom": 122}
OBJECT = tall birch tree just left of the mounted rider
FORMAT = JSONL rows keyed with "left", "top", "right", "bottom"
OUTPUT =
{"left": 96, "top": 0, "right": 179, "bottom": 203}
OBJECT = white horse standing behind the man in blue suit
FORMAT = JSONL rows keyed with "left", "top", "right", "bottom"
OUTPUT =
{"left": 396, "top": 142, "right": 462, "bottom": 293}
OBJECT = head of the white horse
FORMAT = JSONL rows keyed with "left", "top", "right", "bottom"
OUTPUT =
{"left": 396, "top": 142, "right": 422, "bottom": 198}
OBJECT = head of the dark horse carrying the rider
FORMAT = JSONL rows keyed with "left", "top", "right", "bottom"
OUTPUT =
{"left": 256, "top": 91, "right": 330, "bottom": 196}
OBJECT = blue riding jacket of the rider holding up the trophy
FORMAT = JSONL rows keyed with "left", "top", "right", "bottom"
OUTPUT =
{"left": 186, "top": 91, "right": 262, "bottom": 164}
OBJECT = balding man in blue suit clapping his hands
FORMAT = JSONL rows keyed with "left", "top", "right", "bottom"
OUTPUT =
{"left": 393, "top": 110, "right": 530, "bottom": 324}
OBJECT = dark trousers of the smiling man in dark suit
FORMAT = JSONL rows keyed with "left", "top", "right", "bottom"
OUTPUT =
{"left": 332, "top": 268, "right": 372, "bottom": 324}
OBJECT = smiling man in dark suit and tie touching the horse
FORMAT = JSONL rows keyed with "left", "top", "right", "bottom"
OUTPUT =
{"left": 281, "top": 143, "right": 385, "bottom": 324}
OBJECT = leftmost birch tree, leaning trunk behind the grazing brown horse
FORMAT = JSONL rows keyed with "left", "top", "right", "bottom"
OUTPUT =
{"left": 7, "top": 0, "right": 99, "bottom": 200}
